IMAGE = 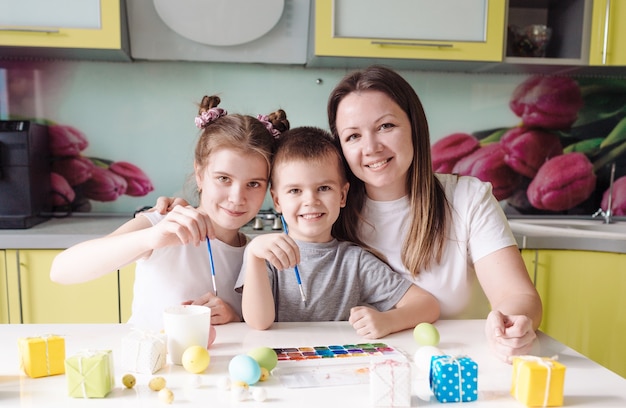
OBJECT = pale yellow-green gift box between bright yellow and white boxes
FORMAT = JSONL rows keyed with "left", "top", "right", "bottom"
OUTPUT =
{"left": 65, "top": 350, "right": 115, "bottom": 398}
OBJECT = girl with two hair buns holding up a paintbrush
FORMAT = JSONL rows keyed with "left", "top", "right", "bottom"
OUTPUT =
{"left": 50, "top": 96, "right": 289, "bottom": 330}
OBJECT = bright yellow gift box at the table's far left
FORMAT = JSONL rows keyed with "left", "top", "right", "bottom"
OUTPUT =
{"left": 17, "top": 335, "right": 65, "bottom": 378}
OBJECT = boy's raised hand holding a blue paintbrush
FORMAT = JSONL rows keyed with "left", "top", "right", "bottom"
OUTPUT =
{"left": 248, "top": 233, "right": 300, "bottom": 271}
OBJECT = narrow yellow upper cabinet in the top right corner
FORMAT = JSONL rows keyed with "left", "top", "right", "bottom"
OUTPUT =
{"left": 589, "top": 0, "right": 626, "bottom": 65}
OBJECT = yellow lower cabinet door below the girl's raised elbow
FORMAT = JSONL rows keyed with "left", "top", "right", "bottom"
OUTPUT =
{"left": 5, "top": 249, "right": 120, "bottom": 323}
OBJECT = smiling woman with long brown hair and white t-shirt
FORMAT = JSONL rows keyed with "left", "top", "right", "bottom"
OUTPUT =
{"left": 327, "top": 66, "right": 542, "bottom": 360}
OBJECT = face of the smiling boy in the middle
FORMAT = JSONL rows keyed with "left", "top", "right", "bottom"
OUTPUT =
{"left": 270, "top": 156, "right": 349, "bottom": 242}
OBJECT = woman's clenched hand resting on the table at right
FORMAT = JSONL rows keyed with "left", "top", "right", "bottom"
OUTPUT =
{"left": 485, "top": 310, "right": 537, "bottom": 364}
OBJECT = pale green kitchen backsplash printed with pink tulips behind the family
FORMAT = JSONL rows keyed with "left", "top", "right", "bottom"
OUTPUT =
{"left": 0, "top": 60, "right": 626, "bottom": 216}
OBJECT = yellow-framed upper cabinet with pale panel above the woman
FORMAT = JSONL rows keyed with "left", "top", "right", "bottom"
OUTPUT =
{"left": 314, "top": 0, "right": 506, "bottom": 61}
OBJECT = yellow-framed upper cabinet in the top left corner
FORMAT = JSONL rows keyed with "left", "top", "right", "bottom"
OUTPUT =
{"left": 0, "top": 0, "right": 130, "bottom": 61}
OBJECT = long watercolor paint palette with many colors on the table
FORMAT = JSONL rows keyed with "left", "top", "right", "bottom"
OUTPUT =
{"left": 274, "top": 343, "right": 405, "bottom": 366}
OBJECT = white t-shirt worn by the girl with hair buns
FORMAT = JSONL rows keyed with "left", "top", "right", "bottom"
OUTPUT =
{"left": 128, "top": 212, "right": 245, "bottom": 331}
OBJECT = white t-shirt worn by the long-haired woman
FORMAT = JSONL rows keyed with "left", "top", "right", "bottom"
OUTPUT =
{"left": 359, "top": 174, "right": 516, "bottom": 319}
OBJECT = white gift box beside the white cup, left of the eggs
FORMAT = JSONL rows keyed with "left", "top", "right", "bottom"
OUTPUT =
{"left": 122, "top": 330, "right": 167, "bottom": 374}
